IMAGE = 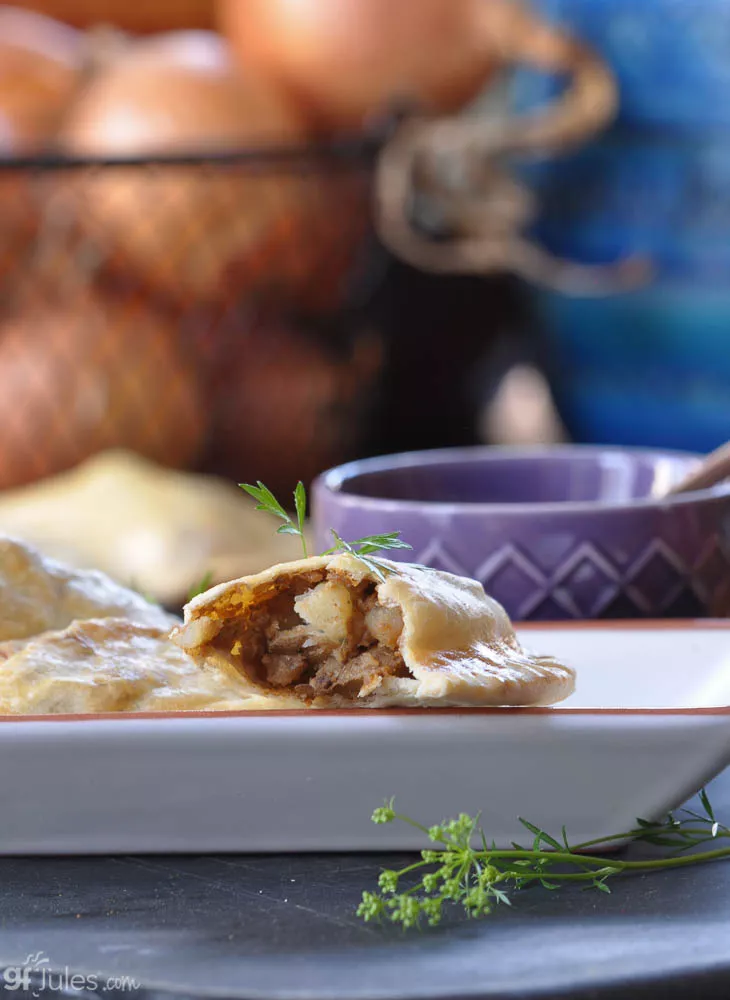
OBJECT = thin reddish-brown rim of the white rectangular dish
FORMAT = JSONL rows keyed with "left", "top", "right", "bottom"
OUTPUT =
{"left": 0, "top": 618, "right": 730, "bottom": 725}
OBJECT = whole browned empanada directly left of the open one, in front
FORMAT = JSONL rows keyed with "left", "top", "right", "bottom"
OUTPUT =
{"left": 0, "top": 618, "right": 280, "bottom": 715}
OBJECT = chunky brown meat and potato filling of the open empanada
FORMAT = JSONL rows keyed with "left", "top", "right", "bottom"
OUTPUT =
{"left": 215, "top": 570, "right": 411, "bottom": 702}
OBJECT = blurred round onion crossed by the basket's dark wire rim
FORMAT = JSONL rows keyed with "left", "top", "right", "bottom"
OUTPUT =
{"left": 59, "top": 32, "right": 305, "bottom": 299}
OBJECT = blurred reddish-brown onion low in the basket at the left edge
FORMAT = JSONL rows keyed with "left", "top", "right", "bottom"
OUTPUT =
{"left": 0, "top": 292, "right": 206, "bottom": 488}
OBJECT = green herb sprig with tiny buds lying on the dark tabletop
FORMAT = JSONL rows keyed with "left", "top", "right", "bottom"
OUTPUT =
{"left": 357, "top": 790, "right": 730, "bottom": 928}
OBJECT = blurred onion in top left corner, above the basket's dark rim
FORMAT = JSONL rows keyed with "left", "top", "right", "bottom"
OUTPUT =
{"left": 0, "top": 5, "right": 85, "bottom": 156}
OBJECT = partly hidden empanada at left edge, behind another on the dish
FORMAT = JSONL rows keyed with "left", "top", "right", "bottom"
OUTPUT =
{"left": 0, "top": 536, "right": 175, "bottom": 644}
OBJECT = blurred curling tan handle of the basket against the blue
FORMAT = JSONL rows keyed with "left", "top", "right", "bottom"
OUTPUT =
{"left": 375, "top": 0, "right": 651, "bottom": 295}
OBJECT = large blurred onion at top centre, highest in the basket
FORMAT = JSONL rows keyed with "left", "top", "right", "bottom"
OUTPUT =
{"left": 218, "top": 0, "right": 494, "bottom": 130}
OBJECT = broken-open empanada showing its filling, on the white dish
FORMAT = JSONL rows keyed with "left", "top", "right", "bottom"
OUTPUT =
{"left": 171, "top": 555, "right": 575, "bottom": 708}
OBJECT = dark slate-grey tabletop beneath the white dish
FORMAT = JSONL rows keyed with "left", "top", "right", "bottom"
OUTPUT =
{"left": 0, "top": 772, "right": 730, "bottom": 1000}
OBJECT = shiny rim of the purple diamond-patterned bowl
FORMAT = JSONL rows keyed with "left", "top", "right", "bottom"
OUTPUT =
{"left": 313, "top": 444, "right": 730, "bottom": 515}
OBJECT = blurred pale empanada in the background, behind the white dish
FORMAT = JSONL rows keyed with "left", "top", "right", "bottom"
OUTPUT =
{"left": 0, "top": 449, "right": 308, "bottom": 607}
